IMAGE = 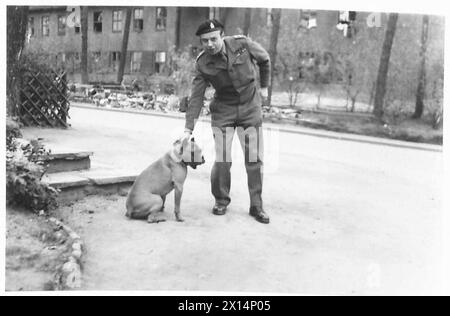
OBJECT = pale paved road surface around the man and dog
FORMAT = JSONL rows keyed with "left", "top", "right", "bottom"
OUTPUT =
{"left": 25, "top": 108, "right": 444, "bottom": 294}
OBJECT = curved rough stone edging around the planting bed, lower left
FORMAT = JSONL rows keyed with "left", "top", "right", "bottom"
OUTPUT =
{"left": 48, "top": 217, "right": 83, "bottom": 290}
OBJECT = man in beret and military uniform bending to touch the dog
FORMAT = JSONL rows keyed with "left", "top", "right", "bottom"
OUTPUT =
{"left": 184, "top": 19, "right": 270, "bottom": 224}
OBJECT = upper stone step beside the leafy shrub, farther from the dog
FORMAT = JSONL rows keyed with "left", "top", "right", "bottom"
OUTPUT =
{"left": 47, "top": 149, "right": 94, "bottom": 173}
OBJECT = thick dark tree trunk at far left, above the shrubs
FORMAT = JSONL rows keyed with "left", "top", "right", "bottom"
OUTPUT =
{"left": 6, "top": 6, "right": 28, "bottom": 116}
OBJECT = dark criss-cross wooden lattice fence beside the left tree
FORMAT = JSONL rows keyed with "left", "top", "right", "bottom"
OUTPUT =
{"left": 18, "top": 70, "right": 70, "bottom": 128}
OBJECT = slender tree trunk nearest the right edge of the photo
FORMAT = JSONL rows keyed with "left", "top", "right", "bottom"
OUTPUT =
{"left": 412, "top": 15, "right": 429, "bottom": 119}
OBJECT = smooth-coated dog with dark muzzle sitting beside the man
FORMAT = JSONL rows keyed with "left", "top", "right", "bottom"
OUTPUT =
{"left": 125, "top": 138, "right": 205, "bottom": 223}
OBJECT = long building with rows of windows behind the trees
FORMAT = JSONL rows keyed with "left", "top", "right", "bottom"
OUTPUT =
{"left": 24, "top": 6, "right": 444, "bottom": 92}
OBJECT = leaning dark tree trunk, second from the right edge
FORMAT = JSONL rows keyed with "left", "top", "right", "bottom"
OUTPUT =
{"left": 373, "top": 13, "right": 398, "bottom": 119}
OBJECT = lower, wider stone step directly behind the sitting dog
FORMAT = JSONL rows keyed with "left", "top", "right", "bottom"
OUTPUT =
{"left": 42, "top": 167, "right": 138, "bottom": 201}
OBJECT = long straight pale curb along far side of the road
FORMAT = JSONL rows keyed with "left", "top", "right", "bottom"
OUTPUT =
{"left": 71, "top": 103, "right": 443, "bottom": 152}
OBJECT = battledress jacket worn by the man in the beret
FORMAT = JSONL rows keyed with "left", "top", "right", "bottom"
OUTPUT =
{"left": 185, "top": 35, "right": 270, "bottom": 131}
